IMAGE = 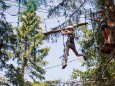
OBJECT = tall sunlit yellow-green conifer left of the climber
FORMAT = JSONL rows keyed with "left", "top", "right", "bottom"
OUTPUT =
{"left": 15, "top": 1, "right": 49, "bottom": 81}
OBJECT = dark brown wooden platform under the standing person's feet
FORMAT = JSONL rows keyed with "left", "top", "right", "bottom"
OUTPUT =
{"left": 100, "top": 43, "right": 115, "bottom": 54}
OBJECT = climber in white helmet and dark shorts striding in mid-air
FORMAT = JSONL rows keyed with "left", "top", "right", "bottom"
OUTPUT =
{"left": 61, "top": 26, "right": 87, "bottom": 69}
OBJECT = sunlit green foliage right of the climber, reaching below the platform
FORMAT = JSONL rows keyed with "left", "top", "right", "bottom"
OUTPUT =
{"left": 72, "top": 10, "right": 115, "bottom": 86}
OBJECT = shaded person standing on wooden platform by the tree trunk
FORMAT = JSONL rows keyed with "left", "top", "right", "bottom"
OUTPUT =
{"left": 97, "top": 9, "right": 110, "bottom": 43}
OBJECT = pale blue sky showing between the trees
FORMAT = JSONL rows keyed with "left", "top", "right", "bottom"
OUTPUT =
{"left": 0, "top": 2, "right": 90, "bottom": 81}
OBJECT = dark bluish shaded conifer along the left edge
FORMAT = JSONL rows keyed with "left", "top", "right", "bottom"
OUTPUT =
{"left": 0, "top": 0, "right": 16, "bottom": 70}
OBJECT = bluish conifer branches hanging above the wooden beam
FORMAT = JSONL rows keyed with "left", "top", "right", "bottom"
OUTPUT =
{"left": 48, "top": 0, "right": 87, "bottom": 28}
